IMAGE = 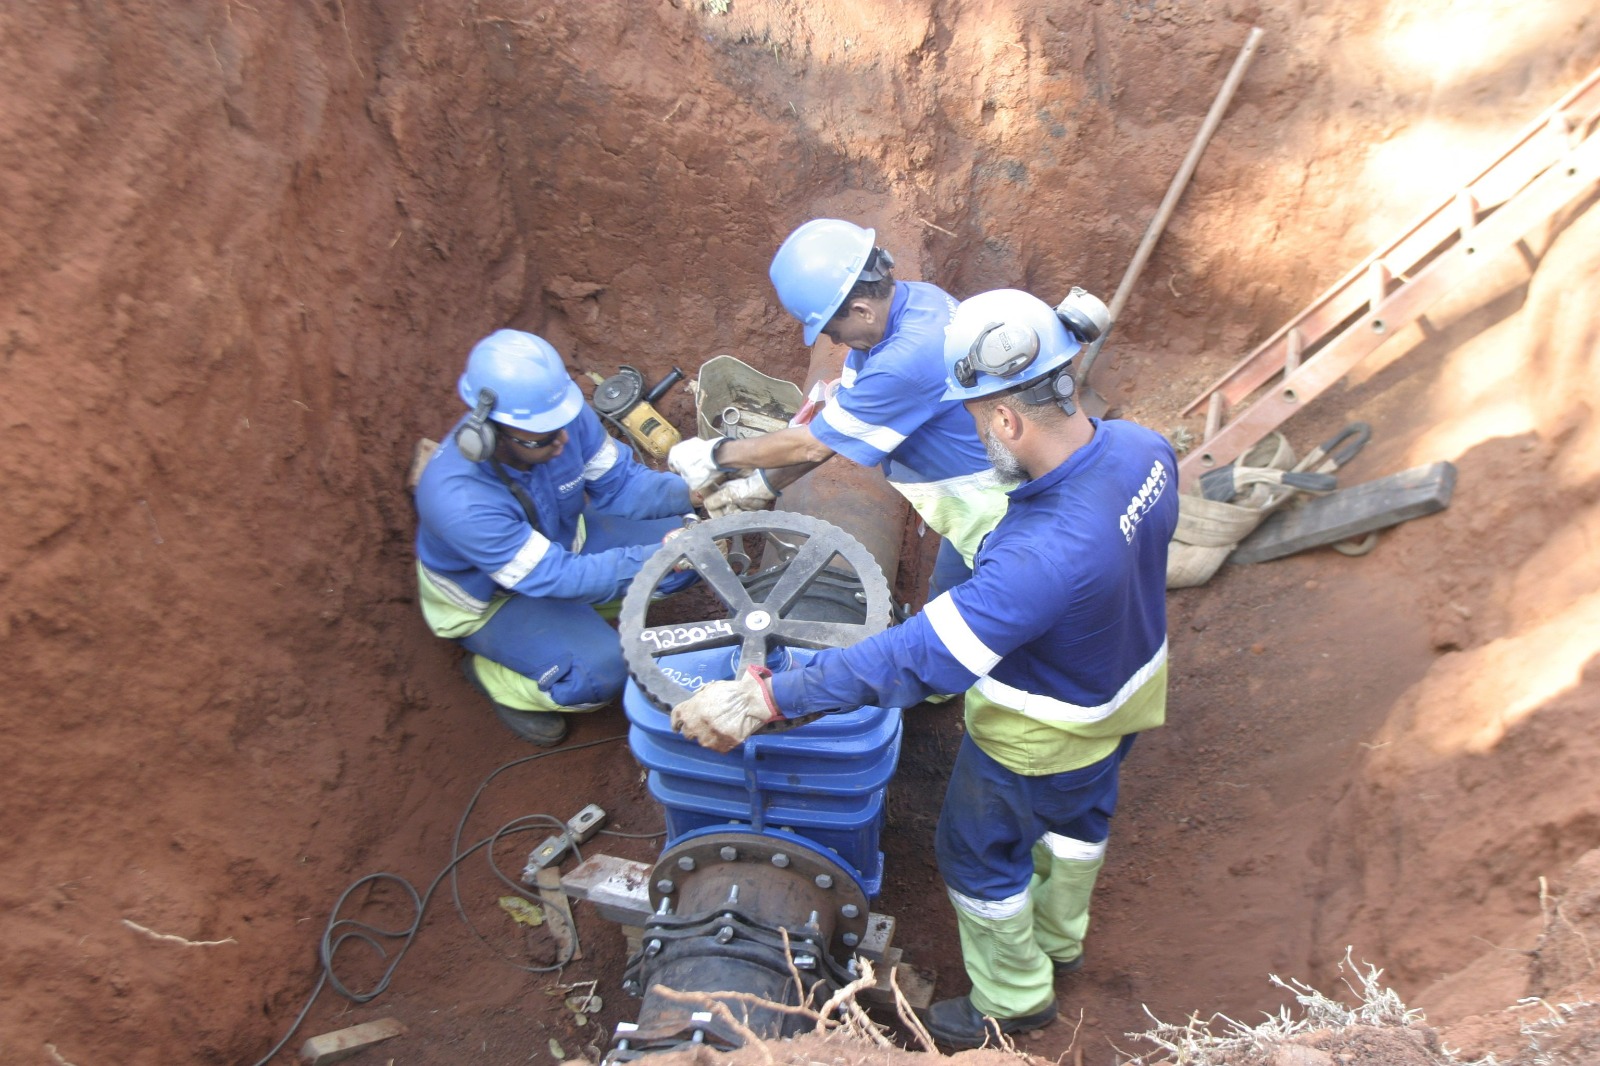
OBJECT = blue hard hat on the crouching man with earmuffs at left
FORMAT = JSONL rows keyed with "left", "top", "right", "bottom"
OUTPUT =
{"left": 456, "top": 330, "right": 584, "bottom": 434}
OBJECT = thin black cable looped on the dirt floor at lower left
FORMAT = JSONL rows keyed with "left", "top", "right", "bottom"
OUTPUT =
{"left": 254, "top": 735, "right": 627, "bottom": 1066}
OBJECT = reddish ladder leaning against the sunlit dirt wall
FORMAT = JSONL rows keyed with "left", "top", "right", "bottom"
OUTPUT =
{"left": 1178, "top": 61, "right": 1600, "bottom": 490}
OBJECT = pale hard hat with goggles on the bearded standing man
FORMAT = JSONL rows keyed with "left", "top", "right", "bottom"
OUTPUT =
{"left": 941, "top": 288, "right": 1082, "bottom": 400}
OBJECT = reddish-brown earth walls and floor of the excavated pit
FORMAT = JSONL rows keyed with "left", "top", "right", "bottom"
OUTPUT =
{"left": 9, "top": 0, "right": 1600, "bottom": 1064}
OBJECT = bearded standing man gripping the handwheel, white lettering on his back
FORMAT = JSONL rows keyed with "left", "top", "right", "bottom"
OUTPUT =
{"left": 672, "top": 290, "right": 1178, "bottom": 1047}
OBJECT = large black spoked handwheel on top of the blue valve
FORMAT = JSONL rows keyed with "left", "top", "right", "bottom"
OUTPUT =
{"left": 616, "top": 511, "right": 891, "bottom": 711}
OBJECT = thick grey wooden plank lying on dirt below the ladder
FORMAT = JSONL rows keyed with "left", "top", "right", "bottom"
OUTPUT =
{"left": 1227, "top": 463, "right": 1456, "bottom": 563}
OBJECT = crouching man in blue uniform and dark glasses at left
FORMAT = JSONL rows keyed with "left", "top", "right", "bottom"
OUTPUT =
{"left": 416, "top": 330, "right": 694, "bottom": 746}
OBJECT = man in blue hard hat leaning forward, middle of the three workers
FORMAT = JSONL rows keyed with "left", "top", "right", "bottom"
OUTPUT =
{"left": 667, "top": 218, "right": 1011, "bottom": 599}
